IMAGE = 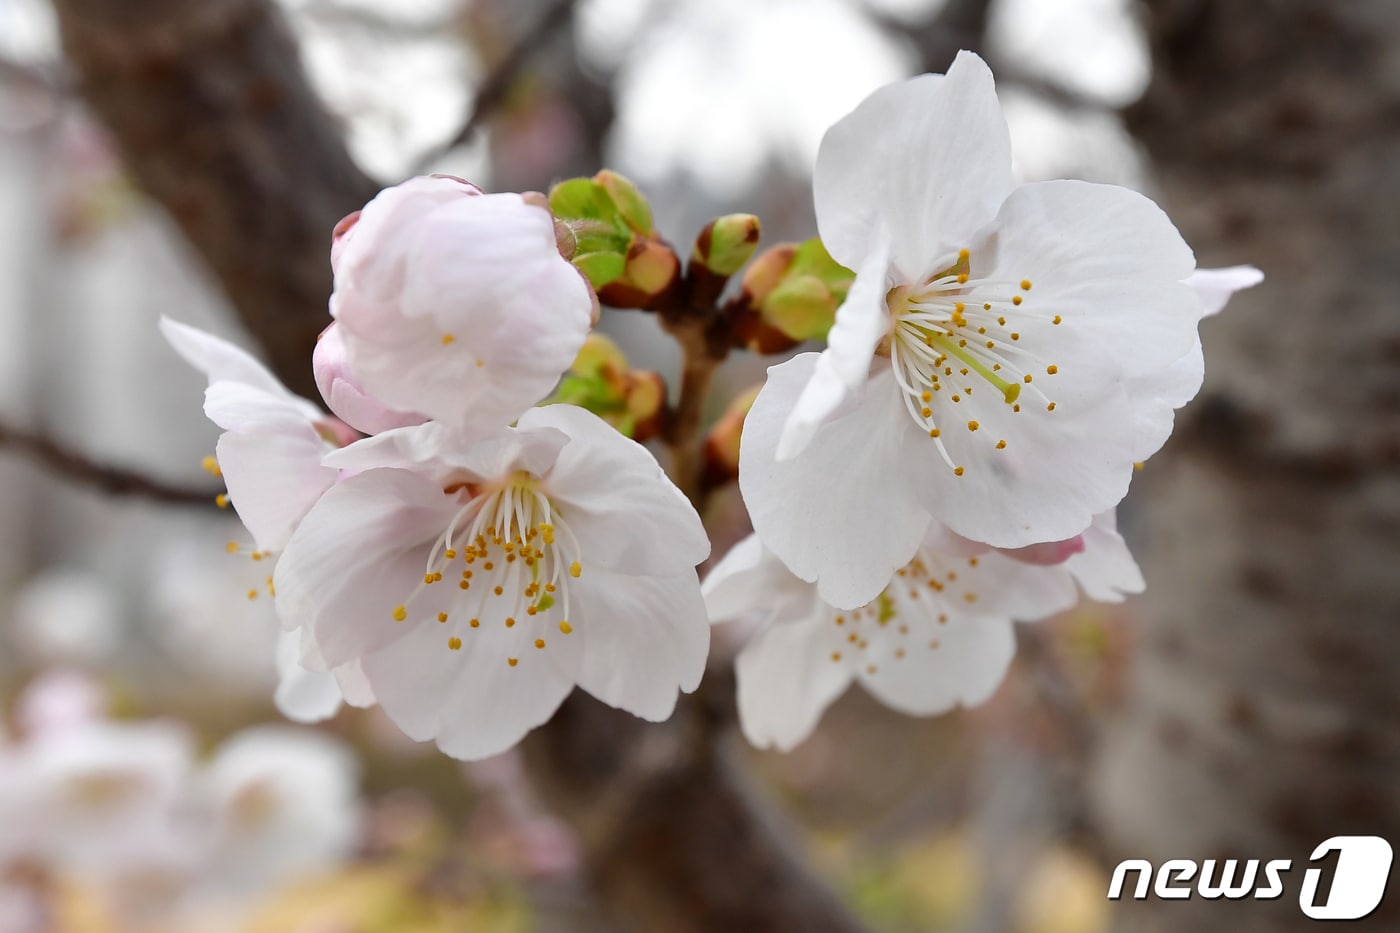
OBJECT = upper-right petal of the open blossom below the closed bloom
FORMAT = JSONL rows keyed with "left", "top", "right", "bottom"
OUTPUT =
{"left": 518, "top": 405, "right": 710, "bottom": 576}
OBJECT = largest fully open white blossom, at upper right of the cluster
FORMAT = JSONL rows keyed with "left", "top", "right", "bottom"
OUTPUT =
{"left": 739, "top": 52, "right": 1260, "bottom": 607}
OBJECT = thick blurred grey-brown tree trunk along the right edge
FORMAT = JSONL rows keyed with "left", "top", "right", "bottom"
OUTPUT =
{"left": 1096, "top": 0, "right": 1400, "bottom": 933}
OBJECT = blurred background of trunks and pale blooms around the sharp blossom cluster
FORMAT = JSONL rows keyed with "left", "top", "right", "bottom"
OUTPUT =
{"left": 0, "top": 0, "right": 1400, "bottom": 933}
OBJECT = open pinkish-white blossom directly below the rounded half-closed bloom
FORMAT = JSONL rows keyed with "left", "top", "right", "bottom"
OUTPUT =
{"left": 276, "top": 405, "right": 710, "bottom": 759}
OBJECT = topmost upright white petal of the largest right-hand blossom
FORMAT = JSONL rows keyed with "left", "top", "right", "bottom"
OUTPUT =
{"left": 812, "top": 52, "right": 1012, "bottom": 279}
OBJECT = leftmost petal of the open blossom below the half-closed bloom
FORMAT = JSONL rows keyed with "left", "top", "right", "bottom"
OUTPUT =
{"left": 273, "top": 469, "right": 461, "bottom": 667}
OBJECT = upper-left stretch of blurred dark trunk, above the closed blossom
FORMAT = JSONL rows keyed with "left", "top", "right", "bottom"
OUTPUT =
{"left": 55, "top": 0, "right": 377, "bottom": 398}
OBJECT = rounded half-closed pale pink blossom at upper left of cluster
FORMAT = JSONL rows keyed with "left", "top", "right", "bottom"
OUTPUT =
{"left": 328, "top": 177, "right": 595, "bottom": 433}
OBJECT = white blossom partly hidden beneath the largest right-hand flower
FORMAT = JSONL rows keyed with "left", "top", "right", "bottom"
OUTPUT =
{"left": 703, "top": 514, "right": 1142, "bottom": 751}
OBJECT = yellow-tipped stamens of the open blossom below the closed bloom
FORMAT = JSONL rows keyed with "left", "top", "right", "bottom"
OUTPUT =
{"left": 393, "top": 471, "right": 582, "bottom": 667}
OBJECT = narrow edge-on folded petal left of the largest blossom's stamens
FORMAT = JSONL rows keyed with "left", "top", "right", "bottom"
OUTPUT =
{"left": 777, "top": 233, "right": 889, "bottom": 459}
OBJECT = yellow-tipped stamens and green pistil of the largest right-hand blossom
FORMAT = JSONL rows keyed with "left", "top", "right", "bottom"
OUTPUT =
{"left": 886, "top": 249, "right": 1063, "bottom": 476}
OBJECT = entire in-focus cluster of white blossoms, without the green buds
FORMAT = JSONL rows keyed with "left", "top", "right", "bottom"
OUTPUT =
{"left": 162, "top": 53, "right": 1260, "bottom": 758}
